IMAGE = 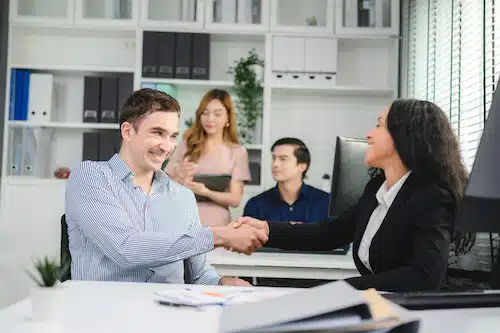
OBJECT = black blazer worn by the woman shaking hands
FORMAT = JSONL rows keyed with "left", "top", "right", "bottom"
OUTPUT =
{"left": 266, "top": 173, "right": 456, "bottom": 292}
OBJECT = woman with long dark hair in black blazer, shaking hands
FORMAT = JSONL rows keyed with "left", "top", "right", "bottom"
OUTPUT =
{"left": 235, "top": 99, "right": 473, "bottom": 291}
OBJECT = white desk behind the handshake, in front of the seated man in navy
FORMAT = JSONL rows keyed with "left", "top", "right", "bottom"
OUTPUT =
{"left": 207, "top": 248, "right": 359, "bottom": 280}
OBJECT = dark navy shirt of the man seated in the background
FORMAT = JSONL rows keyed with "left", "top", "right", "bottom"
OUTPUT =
{"left": 243, "top": 184, "right": 330, "bottom": 223}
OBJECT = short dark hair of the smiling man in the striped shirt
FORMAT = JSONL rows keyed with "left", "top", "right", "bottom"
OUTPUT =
{"left": 120, "top": 88, "right": 181, "bottom": 128}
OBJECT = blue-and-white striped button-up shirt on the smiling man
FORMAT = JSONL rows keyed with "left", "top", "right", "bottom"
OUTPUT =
{"left": 65, "top": 154, "right": 220, "bottom": 284}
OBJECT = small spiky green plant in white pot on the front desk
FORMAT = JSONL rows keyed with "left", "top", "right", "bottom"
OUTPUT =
{"left": 28, "top": 257, "right": 70, "bottom": 321}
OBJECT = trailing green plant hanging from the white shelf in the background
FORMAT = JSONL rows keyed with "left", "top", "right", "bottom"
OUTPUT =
{"left": 228, "top": 49, "right": 264, "bottom": 144}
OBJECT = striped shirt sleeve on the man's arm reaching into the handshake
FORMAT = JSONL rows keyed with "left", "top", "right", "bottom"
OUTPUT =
{"left": 66, "top": 161, "right": 214, "bottom": 269}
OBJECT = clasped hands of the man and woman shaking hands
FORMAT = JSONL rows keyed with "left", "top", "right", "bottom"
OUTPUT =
{"left": 212, "top": 216, "right": 269, "bottom": 255}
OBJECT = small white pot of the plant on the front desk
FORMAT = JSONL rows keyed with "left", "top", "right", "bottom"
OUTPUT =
{"left": 30, "top": 284, "right": 65, "bottom": 321}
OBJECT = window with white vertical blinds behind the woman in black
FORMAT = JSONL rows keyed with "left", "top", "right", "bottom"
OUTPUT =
{"left": 403, "top": 0, "right": 500, "bottom": 171}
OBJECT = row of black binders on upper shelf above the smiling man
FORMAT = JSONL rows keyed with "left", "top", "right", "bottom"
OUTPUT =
{"left": 142, "top": 31, "right": 210, "bottom": 80}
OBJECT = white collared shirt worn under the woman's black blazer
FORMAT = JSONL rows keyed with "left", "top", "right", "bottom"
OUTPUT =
{"left": 358, "top": 170, "right": 411, "bottom": 273}
